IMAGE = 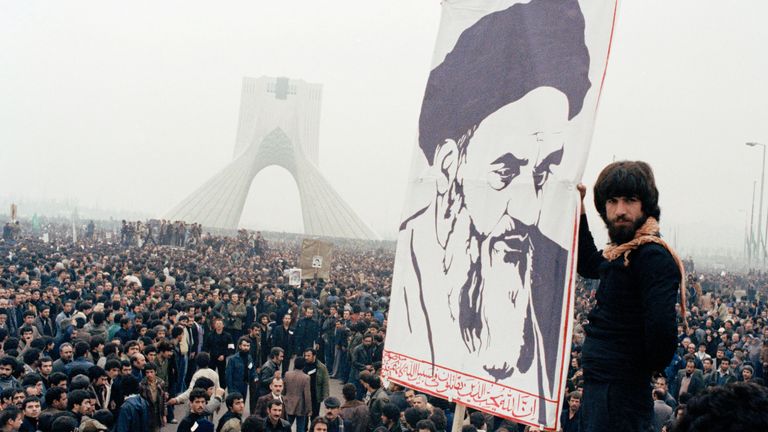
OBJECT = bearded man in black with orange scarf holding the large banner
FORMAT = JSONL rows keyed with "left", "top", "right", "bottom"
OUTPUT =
{"left": 578, "top": 161, "right": 685, "bottom": 432}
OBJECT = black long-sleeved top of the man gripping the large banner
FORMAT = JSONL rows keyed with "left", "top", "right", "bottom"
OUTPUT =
{"left": 578, "top": 215, "right": 681, "bottom": 384}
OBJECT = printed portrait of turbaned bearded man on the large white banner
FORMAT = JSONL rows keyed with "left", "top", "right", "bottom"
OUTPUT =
{"left": 387, "top": 0, "right": 591, "bottom": 422}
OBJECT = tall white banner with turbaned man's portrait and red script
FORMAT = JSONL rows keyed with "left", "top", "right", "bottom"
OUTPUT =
{"left": 382, "top": 0, "right": 618, "bottom": 429}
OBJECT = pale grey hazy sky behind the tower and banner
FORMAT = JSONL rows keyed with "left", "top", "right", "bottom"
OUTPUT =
{"left": 0, "top": 0, "right": 768, "bottom": 260}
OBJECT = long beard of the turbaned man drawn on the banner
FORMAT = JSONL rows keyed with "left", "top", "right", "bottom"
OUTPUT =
{"left": 446, "top": 212, "right": 536, "bottom": 380}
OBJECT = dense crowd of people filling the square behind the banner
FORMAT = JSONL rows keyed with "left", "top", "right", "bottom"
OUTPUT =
{"left": 0, "top": 222, "right": 768, "bottom": 432}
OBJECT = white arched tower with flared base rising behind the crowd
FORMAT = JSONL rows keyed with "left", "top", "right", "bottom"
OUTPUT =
{"left": 165, "top": 77, "right": 378, "bottom": 239}
